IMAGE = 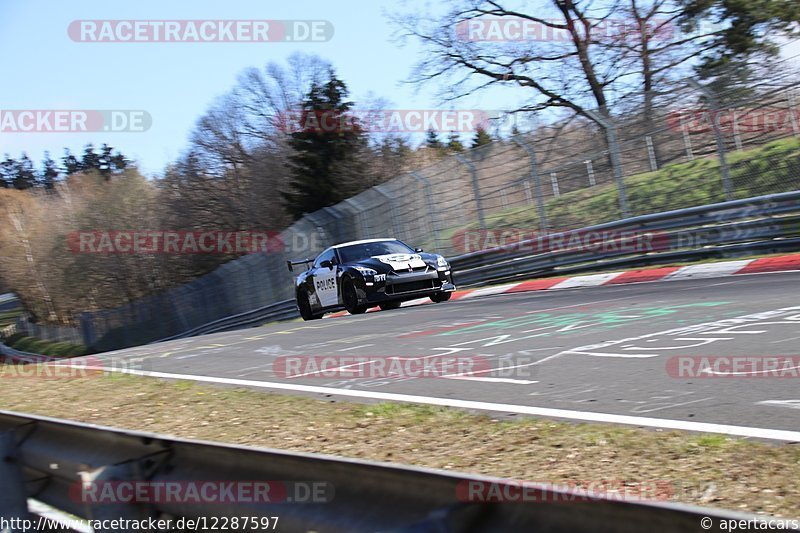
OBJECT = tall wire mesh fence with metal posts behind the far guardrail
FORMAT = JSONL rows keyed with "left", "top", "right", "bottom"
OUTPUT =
{"left": 23, "top": 75, "right": 800, "bottom": 350}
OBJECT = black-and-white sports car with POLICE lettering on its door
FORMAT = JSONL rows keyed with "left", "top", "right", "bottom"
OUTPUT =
{"left": 287, "top": 239, "right": 456, "bottom": 320}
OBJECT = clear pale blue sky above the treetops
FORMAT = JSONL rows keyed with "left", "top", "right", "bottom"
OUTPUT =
{"left": 0, "top": 0, "right": 800, "bottom": 176}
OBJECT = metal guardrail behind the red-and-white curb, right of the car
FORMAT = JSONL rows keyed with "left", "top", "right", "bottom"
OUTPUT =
{"left": 450, "top": 191, "right": 800, "bottom": 286}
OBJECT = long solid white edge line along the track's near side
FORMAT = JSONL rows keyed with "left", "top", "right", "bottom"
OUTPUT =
{"left": 108, "top": 367, "right": 800, "bottom": 442}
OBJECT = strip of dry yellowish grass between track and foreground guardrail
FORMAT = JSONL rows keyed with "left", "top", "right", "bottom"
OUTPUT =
{"left": 0, "top": 367, "right": 800, "bottom": 516}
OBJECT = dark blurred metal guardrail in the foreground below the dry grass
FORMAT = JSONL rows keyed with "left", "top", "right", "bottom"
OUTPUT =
{"left": 0, "top": 411, "right": 780, "bottom": 533}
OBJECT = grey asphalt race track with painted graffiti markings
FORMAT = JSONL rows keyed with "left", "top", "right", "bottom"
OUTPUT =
{"left": 89, "top": 273, "right": 800, "bottom": 440}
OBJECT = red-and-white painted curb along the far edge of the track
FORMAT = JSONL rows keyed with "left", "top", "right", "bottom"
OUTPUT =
{"left": 325, "top": 254, "right": 800, "bottom": 318}
